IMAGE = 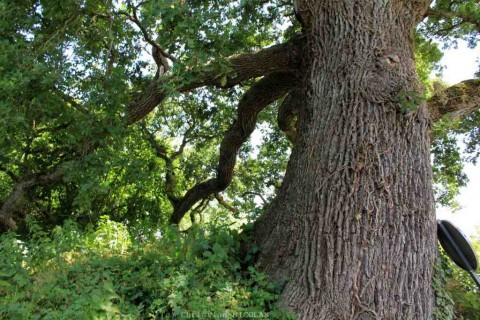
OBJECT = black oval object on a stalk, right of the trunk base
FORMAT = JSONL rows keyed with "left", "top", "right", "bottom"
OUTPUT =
{"left": 437, "top": 220, "right": 478, "bottom": 271}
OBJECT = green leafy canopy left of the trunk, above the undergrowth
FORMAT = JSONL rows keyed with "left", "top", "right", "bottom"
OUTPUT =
{"left": 0, "top": 0, "right": 289, "bottom": 230}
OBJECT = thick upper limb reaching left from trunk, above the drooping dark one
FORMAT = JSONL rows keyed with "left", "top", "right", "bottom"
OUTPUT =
{"left": 125, "top": 37, "right": 303, "bottom": 124}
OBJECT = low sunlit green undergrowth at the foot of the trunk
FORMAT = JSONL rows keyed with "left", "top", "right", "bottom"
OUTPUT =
{"left": 0, "top": 217, "right": 289, "bottom": 319}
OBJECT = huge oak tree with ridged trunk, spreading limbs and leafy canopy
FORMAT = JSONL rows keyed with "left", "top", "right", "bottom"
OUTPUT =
{"left": 0, "top": 0, "right": 480, "bottom": 319}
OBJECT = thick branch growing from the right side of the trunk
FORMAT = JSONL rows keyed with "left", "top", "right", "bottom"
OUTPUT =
{"left": 427, "top": 79, "right": 480, "bottom": 122}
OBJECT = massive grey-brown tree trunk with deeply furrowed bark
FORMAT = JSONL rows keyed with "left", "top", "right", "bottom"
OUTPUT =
{"left": 254, "top": 1, "right": 435, "bottom": 320}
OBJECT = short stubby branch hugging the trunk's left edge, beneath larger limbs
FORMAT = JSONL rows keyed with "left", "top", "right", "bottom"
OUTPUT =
{"left": 277, "top": 90, "right": 301, "bottom": 143}
